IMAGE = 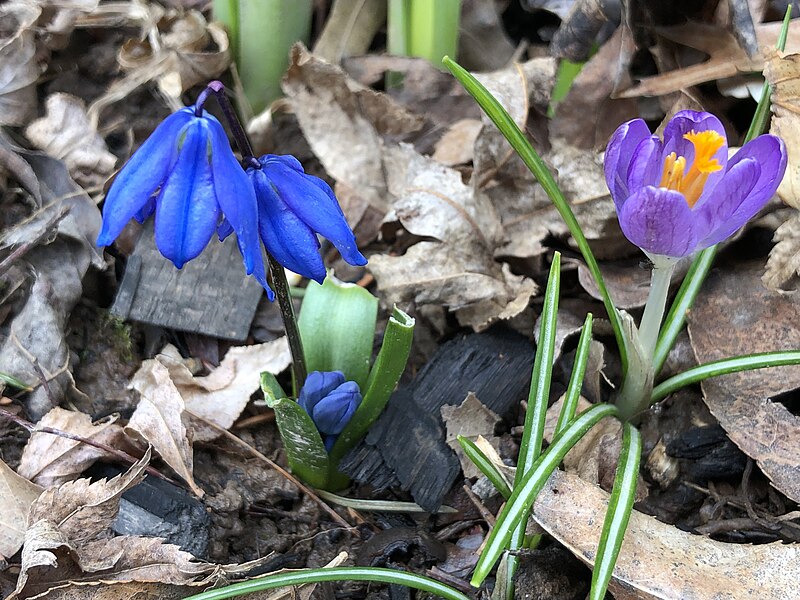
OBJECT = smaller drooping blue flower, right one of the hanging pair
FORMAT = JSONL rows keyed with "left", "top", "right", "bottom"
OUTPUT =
{"left": 247, "top": 154, "right": 367, "bottom": 283}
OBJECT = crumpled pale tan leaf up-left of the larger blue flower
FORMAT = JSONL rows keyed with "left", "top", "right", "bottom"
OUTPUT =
{"left": 25, "top": 93, "right": 117, "bottom": 188}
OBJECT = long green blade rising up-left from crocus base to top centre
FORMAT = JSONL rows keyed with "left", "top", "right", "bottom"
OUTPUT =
{"left": 442, "top": 57, "right": 628, "bottom": 372}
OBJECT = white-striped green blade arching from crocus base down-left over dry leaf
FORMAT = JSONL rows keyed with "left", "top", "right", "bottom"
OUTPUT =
{"left": 471, "top": 404, "right": 619, "bottom": 587}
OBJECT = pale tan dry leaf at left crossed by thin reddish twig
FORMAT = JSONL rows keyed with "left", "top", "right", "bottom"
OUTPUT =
{"left": 18, "top": 407, "right": 122, "bottom": 488}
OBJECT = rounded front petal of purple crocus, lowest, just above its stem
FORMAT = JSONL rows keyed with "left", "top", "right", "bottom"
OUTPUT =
{"left": 617, "top": 186, "right": 697, "bottom": 258}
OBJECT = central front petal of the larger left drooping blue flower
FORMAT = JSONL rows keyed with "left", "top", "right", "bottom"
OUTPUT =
{"left": 155, "top": 118, "right": 219, "bottom": 269}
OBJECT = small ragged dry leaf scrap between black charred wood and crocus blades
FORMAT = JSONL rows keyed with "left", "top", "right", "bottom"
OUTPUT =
{"left": 441, "top": 392, "right": 502, "bottom": 479}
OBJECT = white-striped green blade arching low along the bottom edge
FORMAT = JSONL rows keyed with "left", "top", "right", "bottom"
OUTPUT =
{"left": 178, "top": 567, "right": 471, "bottom": 600}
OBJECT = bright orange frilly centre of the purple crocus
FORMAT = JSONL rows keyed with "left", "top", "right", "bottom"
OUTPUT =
{"left": 660, "top": 131, "right": 725, "bottom": 207}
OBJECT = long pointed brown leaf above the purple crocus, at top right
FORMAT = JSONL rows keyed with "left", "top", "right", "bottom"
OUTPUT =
{"left": 619, "top": 19, "right": 800, "bottom": 98}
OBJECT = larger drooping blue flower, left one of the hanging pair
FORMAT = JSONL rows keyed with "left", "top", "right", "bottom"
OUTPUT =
{"left": 97, "top": 107, "right": 273, "bottom": 299}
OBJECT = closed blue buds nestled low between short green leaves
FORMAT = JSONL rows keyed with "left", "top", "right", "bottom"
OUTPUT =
{"left": 297, "top": 371, "right": 361, "bottom": 452}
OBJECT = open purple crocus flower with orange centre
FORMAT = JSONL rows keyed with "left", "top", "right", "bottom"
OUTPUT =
{"left": 605, "top": 110, "right": 786, "bottom": 258}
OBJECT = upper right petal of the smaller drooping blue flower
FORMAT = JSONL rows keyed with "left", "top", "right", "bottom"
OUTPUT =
{"left": 262, "top": 157, "right": 367, "bottom": 265}
